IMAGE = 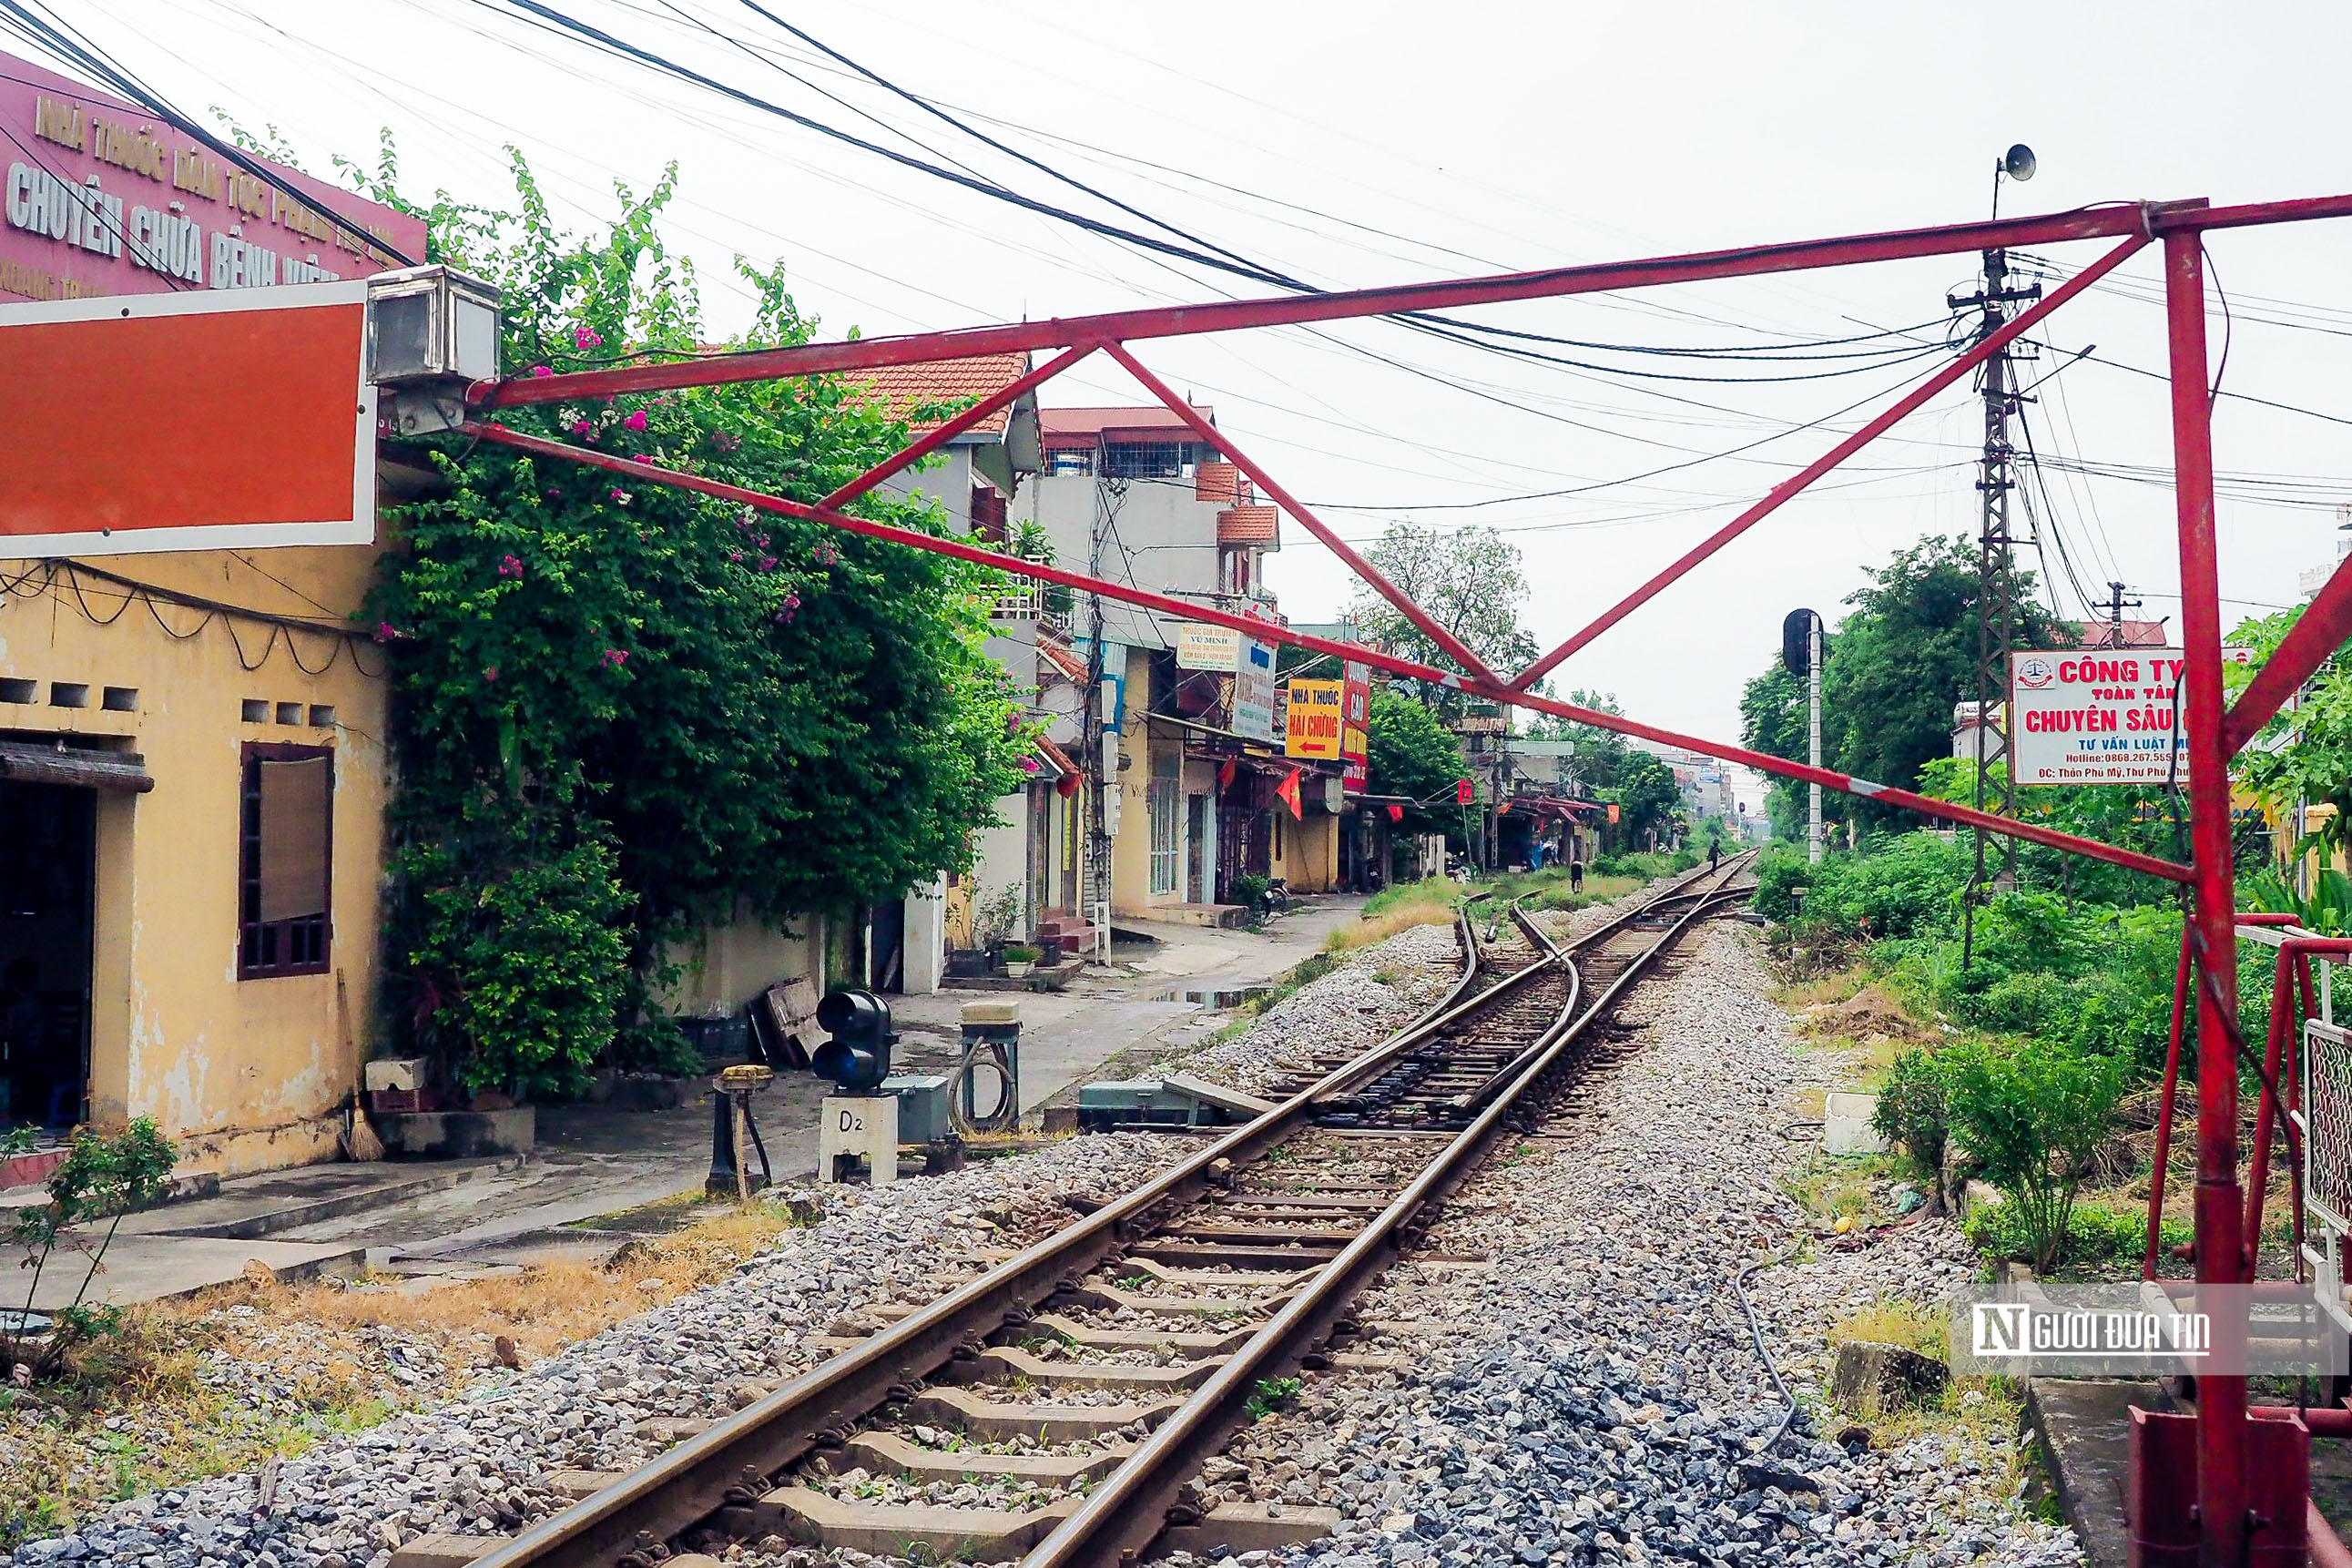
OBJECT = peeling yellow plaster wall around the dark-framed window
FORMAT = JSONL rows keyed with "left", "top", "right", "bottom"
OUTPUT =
{"left": 0, "top": 545, "right": 388, "bottom": 1176}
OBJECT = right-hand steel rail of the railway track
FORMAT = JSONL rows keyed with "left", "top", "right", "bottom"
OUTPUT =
{"left": 1021, "top": 860, "right": 1759, "bottom": 1568}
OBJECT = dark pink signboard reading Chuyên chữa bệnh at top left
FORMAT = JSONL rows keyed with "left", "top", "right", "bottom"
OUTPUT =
{"left": 0, "top": 54, "right": 426, "bottom": 303}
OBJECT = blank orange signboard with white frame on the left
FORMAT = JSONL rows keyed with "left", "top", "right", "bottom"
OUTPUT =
{"left": 0, "top": 282, "right": 376, "bottom": 557}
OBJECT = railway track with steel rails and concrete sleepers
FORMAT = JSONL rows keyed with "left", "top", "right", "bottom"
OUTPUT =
{"left": 453, "top": 856, "right": 1747, "bottom": 1568}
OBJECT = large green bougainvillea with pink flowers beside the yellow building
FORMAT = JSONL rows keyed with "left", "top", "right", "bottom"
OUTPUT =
{"left": 374, "top": 155, "right": 1023, "bottom": 1093}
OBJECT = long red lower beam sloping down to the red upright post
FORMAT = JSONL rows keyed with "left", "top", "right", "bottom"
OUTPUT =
{"left": 461, "top": 421, "right": 2190, "bottom": 881}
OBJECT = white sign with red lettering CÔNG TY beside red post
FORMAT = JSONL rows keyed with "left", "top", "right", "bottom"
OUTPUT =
{"left": 2009, "top": 649, "right": 2246, "bottom": 788}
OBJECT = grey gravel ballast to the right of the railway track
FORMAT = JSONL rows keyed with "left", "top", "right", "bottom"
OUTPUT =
{"left": 1204, "top": 926, "right": 2082, "bottom": 1568}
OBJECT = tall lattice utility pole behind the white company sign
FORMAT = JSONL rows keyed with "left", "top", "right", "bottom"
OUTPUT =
{"left": 1945, "top": 216, "right": 2041, "bottom": 969}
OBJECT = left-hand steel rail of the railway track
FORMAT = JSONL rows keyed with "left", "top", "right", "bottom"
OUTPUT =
{"left": 473, "top": 898, "right": 1550, "bottom": 1568}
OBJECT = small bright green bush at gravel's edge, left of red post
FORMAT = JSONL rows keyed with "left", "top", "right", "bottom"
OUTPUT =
{"left": 1936, "top": 1039, "right": 2126, "bottom": 1269}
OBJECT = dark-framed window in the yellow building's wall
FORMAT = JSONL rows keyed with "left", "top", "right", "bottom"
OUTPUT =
{"left": 238, "top": 745, "right": 334, "bottom": 981}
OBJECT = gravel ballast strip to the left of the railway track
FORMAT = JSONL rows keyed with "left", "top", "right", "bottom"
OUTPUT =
{"left": 0, "top": 1135, "right": 1195, "bottom": 1568}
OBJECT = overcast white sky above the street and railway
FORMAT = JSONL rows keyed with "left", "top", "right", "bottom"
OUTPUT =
{"left": 32, "top": 0, "right": 2352, "bottom": 799}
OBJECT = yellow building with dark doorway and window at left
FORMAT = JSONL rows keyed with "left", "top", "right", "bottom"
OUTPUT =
{"left": 0, "top": 545, "right": 386, "bottom": 1173}
